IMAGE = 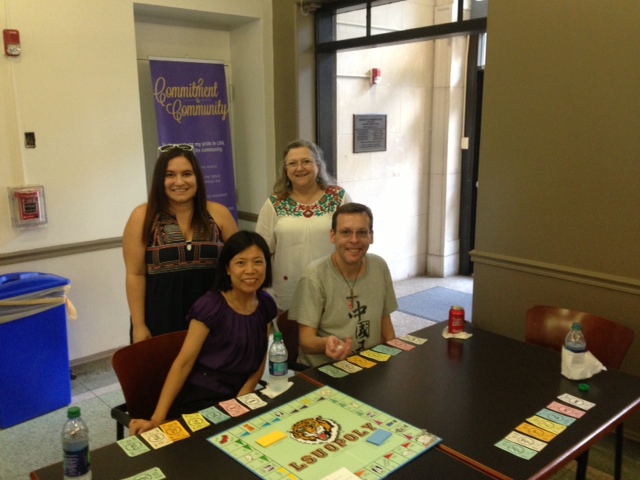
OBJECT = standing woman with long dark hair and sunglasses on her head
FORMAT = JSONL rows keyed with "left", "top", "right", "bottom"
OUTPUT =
{"left": 122, "top": 145, "right": 238, "bottom": 342}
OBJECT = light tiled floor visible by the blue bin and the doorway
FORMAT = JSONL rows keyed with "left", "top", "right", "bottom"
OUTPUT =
{"left": 0, "top": 277, "right": 640, "bottom": 480}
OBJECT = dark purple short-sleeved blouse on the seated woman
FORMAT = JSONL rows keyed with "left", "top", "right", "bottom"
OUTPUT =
{"left": 187, "top": 290, "right": 277, "bottom": 397}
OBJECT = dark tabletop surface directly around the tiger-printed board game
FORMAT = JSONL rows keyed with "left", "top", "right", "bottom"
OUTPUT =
{"left": 31, "top": 378, "right": 490, "bottom": 480}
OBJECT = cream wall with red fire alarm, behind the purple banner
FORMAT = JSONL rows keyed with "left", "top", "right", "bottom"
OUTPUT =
{"left": 0, "top": 0, "right": 274, "bottom": 361}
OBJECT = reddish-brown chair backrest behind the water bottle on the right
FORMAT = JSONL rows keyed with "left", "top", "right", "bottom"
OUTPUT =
{"left": 526, "top": 305, "right": 633, "bottom": 370}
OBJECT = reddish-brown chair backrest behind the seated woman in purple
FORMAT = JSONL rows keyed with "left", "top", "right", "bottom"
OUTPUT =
{"left": 111, "top": 330, "right": 187, "bottom": 418}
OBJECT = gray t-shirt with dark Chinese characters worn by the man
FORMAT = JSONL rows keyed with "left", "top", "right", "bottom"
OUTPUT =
{"left": 289, "top": 253, "right": 398, "bottom": 367}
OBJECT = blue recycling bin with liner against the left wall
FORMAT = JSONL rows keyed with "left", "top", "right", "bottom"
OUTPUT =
{"left": 0, "top": 272, "right": 71, "bottom": 428}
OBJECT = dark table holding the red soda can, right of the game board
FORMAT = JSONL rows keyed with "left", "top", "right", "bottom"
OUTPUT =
{"left": 301, "top": 323, "right": 640, "bottom": 478}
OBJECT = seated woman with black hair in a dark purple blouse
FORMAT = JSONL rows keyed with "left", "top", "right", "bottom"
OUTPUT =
{"left": 129, "top": 231, "right": 277, "bottom": 435}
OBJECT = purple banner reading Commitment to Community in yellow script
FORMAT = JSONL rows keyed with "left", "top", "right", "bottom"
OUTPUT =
{"left": 149, "top": 60, "right": 238, "bottom": 220}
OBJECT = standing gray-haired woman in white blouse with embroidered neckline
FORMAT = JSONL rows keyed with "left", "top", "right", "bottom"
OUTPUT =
{"left": 256, "top": 140, "right": 351, "bottom": 312}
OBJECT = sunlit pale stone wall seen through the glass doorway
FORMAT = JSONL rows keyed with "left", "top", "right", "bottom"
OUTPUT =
{"left": 337, "top": 0, "right": 466, "bottom": 280}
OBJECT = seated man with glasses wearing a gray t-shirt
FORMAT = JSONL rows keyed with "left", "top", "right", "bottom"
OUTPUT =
{"left": 289, "top": 203, "right": 398, "bottom": 367}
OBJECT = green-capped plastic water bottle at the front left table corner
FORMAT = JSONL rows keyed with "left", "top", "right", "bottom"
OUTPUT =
{"left": 62, "top": 407, "right": 91, "bottom": 480}
